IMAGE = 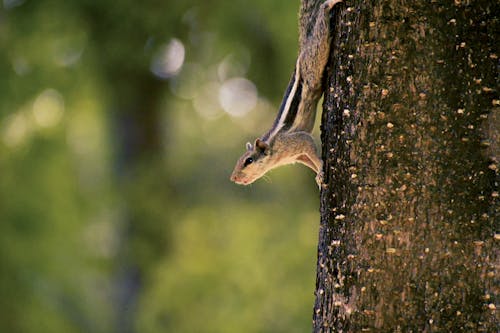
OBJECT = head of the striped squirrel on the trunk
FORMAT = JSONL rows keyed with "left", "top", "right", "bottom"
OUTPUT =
{"left": 230, "top": 139, "right": 271, "bottom": 185}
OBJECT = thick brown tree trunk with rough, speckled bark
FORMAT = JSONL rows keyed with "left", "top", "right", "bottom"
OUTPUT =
{"left": 313, "top": 0, "right": 500, "bottom": 332}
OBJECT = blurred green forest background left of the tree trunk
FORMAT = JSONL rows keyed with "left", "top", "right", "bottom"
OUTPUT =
{"left": 0, "top": 0, "right": 319, "bottom": 333}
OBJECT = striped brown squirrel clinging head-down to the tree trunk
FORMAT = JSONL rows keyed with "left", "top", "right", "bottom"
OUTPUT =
{"left": 230, "top": 0, "right": 342, "bottom": 186}
